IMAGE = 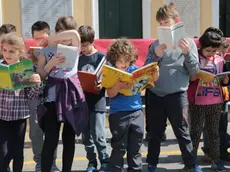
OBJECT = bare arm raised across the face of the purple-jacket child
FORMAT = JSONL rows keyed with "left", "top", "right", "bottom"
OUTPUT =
{"left": 48, "top": 30, "right": 81, "bottom": 47}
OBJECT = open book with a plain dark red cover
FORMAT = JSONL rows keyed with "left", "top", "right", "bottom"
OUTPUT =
{"left": 78, "top": 56, "right": 106, "bottom": 94}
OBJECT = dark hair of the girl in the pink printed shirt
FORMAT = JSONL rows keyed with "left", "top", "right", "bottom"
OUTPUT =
{"left": 199, "top": 27, "right": 223, "bottom": 50}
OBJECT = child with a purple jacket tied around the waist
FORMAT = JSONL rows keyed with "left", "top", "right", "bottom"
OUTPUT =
{"left": 38, "top": 16, "right": 87, "bottom": 172}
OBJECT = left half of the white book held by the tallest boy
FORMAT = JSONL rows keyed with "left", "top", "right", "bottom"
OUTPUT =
{"left": 157, "top": 26, "right": 173, "bottom": 50}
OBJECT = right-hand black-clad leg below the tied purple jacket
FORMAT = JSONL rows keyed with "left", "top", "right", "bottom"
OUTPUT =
{"left": 62, "top": 122, "right": 75, "bottom": 172}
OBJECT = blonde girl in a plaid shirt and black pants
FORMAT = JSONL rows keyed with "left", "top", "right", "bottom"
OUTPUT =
{"left": 0, "top": 33, "right": 41, "bottom": 172}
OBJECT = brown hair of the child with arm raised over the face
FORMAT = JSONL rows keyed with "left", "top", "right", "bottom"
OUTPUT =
{"left": 55, "top": 16, "right": 77, "bottom": 33}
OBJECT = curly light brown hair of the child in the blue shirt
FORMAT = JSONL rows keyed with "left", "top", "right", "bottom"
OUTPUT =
{"left": 106, "top": 38, "right": 138, "bottom": 66}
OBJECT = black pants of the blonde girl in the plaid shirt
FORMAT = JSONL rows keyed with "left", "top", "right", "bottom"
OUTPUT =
{"left": 0, "top": 119, "right": 26, "bottom": 172}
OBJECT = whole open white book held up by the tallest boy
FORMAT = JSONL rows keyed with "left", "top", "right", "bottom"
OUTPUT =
{"left": 157, "top": 22, "right": 186, "bottom": 50}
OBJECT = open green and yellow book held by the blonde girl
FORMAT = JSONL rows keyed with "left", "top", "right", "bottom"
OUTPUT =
{"left": 0, "top": 60, "right": 35, "bottom": 90}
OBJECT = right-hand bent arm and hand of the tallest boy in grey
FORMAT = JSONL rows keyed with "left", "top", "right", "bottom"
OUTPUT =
{"left": 179, "top": 40, "right": 200, "bottom": 76}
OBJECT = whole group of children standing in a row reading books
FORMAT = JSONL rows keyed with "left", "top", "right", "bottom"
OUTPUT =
{"left": 0, "top": 3, "right": 229, "bottom": 172}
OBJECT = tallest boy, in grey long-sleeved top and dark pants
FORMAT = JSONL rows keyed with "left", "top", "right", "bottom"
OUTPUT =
{"left": 145, "top": 3, "right": 202, "bottom": 172}
